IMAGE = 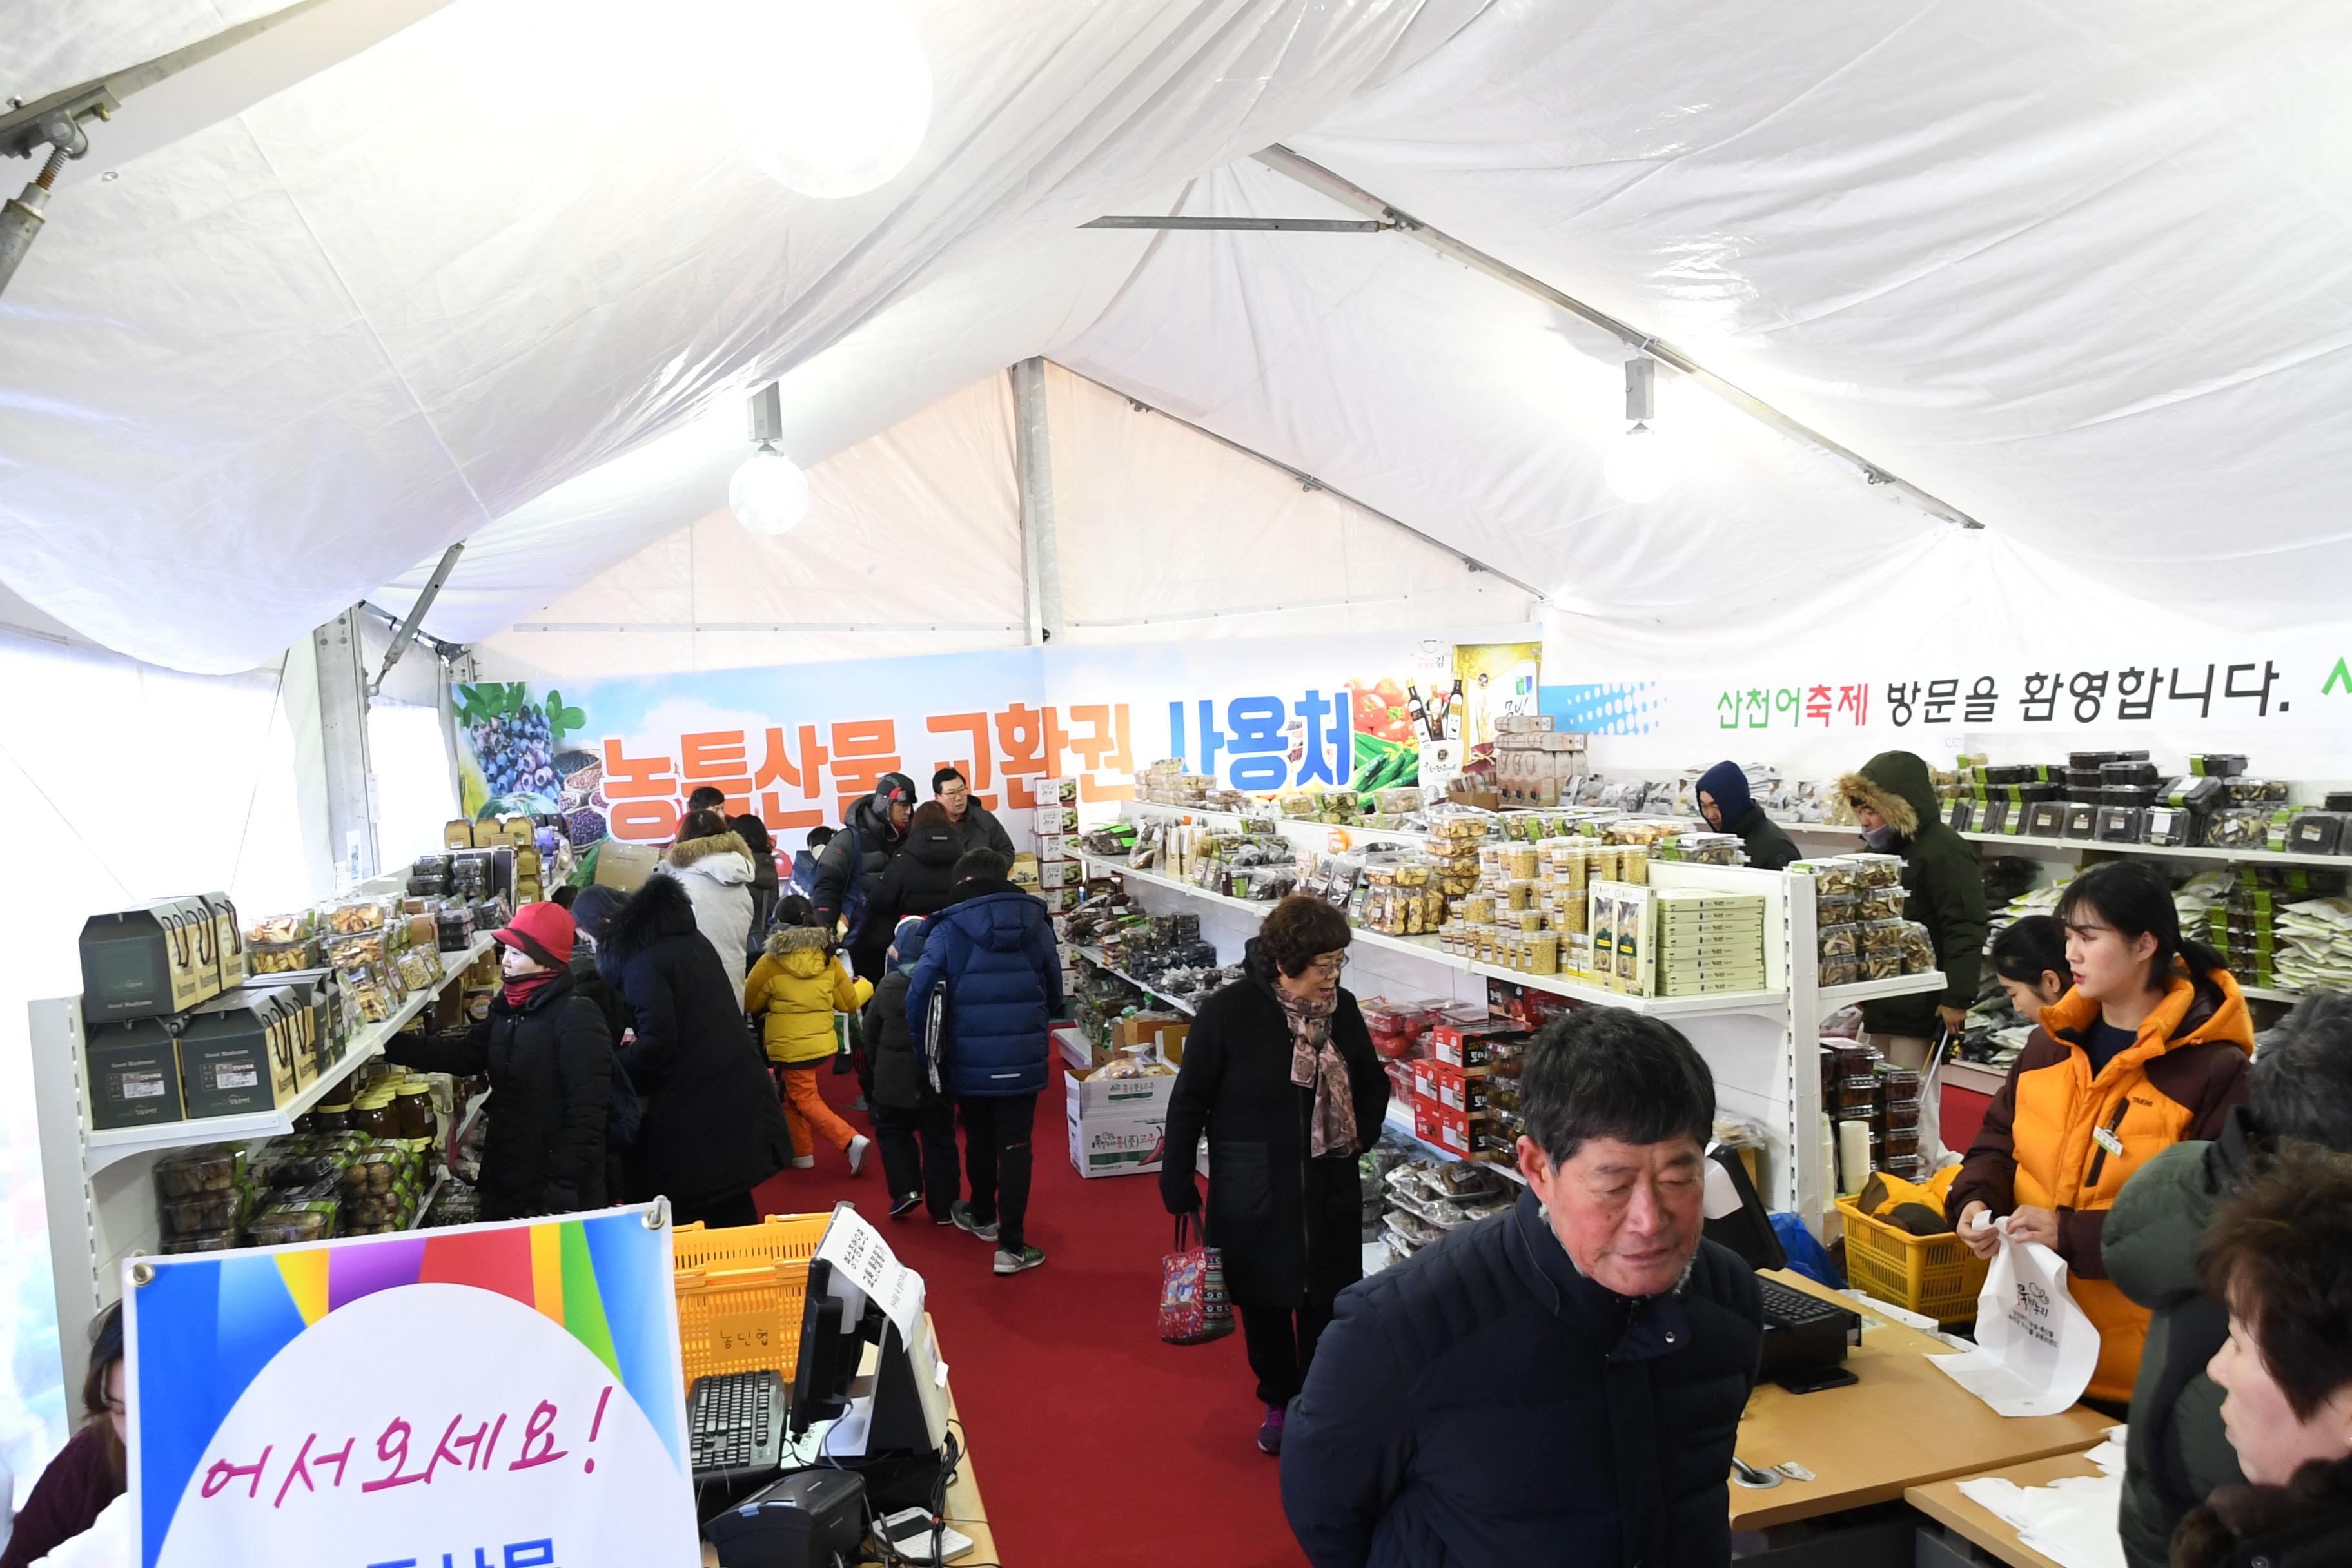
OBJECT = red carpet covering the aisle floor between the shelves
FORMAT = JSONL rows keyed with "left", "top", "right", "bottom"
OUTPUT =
{"left": 760, "top": 1067, "right": 1306, "bottom": 1568}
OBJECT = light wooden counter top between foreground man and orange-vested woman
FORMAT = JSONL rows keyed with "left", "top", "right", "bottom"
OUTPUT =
{"left": 1731, "top": 1272, "right": 2115, "bottom": 1531}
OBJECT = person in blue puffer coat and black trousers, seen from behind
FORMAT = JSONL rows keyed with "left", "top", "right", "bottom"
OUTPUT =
{"left": 905, "top": 848, "right": 1061, "bottom": 1274}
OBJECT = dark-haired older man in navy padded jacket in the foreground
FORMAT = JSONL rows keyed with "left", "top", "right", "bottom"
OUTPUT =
{"left": 1279, "top": 1006, "right": 1764, "bottom": 1568}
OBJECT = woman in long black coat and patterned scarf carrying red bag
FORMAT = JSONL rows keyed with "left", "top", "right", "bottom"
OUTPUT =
{"left": 1159, "top": 894, "right": 1387, "bottom": 1453}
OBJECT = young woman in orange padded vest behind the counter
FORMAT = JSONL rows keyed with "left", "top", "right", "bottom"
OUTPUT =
{"left": 1945, "top": 861, "right": 2253, "bottom": 1406}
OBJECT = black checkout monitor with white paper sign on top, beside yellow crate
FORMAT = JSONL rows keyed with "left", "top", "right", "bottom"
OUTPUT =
{"left": 790, "top": 1204, "right": 948, "bottom": 1460}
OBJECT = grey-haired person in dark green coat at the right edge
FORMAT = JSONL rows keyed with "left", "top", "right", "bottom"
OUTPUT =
{"left": 2098, "top": 994, "right": 2352, "bottom": 1568}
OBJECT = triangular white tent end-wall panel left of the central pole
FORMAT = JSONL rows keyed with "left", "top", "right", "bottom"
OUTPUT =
{"left": 475, "top": 371, "right": 1028, "bottom": 681}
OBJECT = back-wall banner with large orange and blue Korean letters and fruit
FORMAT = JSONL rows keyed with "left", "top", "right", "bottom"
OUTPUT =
{"left": 451, "top": 634, "right": 1486, "bottom": 848}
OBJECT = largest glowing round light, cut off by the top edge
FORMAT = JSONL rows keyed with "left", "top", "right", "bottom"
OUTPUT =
{"left": 727, "top": 0, "right": 932, "bottom": 197}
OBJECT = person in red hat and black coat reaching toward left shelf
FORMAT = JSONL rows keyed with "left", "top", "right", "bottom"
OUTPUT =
{"left": 386, "top": 903, "right": 611, "bottom": 1220}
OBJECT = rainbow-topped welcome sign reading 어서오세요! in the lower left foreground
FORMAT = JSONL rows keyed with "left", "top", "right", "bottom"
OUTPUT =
{"left": 124, "top": 1208, "right": 698, "bottom": 1568}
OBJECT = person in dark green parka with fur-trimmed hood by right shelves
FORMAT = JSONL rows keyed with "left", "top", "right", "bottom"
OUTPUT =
{"left": 1837, "top": 752, "right": 1990, "bottom": 1171}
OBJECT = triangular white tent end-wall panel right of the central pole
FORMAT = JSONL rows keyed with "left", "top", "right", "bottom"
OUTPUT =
{"left": 1046, "top": 364, "right": 1531, "bottom": 642}
